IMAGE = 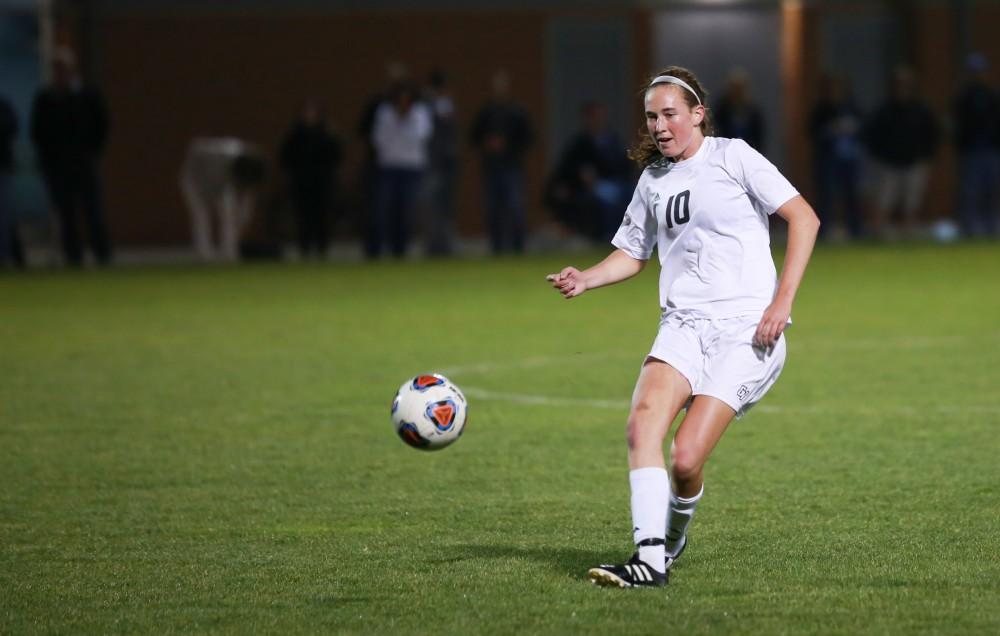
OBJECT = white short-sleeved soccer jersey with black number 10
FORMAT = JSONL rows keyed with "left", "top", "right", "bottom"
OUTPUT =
{"left": 611, "top": 137, "right": 798, "bottom": 318}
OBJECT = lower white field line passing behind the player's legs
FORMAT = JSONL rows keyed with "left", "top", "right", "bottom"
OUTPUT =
{"left": 462, "top": 387, "right": 1000, "bottom": 417}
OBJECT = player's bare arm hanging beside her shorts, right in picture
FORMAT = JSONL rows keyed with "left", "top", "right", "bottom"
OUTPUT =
{"left": 753, "top": 196, "right": 819, "bottom": 347}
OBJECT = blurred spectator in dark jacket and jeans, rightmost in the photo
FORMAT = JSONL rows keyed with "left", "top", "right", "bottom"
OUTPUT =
{"left": 954, "top": 53, "right": 1000, "bottom": 236}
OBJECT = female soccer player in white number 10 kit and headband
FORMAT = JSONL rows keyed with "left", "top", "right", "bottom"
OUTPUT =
{"left": 547, "top": 66, "right": 819, "bottom": 587}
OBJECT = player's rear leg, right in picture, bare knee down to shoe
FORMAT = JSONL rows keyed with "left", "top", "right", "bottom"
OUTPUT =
{"left": 664, "top": 395, "right": 736, "bottom": 566}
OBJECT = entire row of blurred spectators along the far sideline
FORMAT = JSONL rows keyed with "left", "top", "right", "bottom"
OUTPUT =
{"left": 0, "top": 49, "right": 1000, "bottom": 267}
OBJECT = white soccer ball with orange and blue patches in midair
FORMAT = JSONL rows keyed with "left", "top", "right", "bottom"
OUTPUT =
{"left": 392, "top": 373, "right": 468, "bottom": 450}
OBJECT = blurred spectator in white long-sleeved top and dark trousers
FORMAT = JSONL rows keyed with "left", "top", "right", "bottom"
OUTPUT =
{"left": 365, "top": 82, "right": 434, "bottom": 258}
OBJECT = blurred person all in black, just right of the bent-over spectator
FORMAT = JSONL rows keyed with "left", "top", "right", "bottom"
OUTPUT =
{"left": 280, "top": 99, "right": 341, "bottom": 258}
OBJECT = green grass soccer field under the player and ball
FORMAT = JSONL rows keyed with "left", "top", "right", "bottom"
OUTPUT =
{"left": 0, "top": 244, "right": 1000, "bottom": 635}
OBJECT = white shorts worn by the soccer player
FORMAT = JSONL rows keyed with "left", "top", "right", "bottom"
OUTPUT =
{"left": 649, "top": 313, "right": 785, "bottom": 417}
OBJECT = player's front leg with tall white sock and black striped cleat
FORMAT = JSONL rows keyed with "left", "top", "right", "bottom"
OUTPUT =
{"left": 590, "top": 358, "right": 691, "bottom": 587}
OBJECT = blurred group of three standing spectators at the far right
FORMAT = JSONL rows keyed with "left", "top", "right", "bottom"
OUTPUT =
{"left": 809, "top": 54, "right": 1000, "bottom": 240}
